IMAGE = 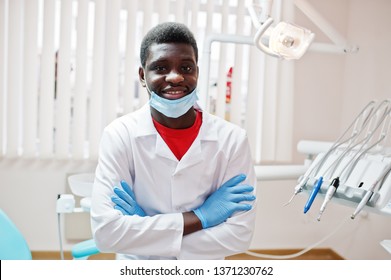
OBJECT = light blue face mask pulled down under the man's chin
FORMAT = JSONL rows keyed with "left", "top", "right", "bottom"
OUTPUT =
{"left": 149, "top": 89, "right": 198, "bottom": 118}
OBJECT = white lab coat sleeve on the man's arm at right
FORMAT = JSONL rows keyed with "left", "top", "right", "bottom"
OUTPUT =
{"left": 178, "top": 130, "right": 257, "bottom": 259}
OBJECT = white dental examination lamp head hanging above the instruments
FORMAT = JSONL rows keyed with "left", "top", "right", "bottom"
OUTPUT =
{"left": 248, "top": 0, "right": 315, "bottom": 60}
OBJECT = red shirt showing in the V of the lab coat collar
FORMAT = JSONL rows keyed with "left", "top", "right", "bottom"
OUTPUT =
{"left": 152, "top": 111, "right": 202, "bottom": 160}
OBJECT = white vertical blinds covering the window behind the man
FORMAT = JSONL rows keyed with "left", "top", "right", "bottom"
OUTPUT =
{"left": 0, "top": 0, "right": 293, "bottom": 162}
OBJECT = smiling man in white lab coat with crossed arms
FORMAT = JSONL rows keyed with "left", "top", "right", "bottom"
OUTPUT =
{"left": 91, "top": 23, "right": 256, "bottom": 259}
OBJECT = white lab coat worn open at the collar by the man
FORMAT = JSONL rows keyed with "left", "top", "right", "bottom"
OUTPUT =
{"left": 91, "top": 104, "right": 256, "bottom": 259}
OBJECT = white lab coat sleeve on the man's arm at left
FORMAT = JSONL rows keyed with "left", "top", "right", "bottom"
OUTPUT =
{"left": 91, "top": 123, "right": 183, "bottom": 257}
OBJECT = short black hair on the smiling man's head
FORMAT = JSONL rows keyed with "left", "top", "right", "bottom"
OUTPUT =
{"left": 140, "top": 22, "right": 198, "bottom": 67}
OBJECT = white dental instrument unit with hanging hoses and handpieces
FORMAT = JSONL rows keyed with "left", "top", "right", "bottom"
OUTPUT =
{"left": 288, "top": 99, "right": 391, "bottom": 221}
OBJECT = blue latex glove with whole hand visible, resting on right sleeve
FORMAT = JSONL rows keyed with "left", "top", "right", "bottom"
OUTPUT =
{"left": 193, "top": 174, "right": 255, "bottom": 228}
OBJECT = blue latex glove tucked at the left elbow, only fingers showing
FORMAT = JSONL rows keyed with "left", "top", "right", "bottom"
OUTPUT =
{"left": 111, "top": 181, "right": 146, "bottom": 217}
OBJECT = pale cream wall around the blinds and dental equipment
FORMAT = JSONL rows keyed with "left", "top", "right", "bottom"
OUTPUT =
{"left": 0, "top": 0, "right": 391, "bottom": 259}
